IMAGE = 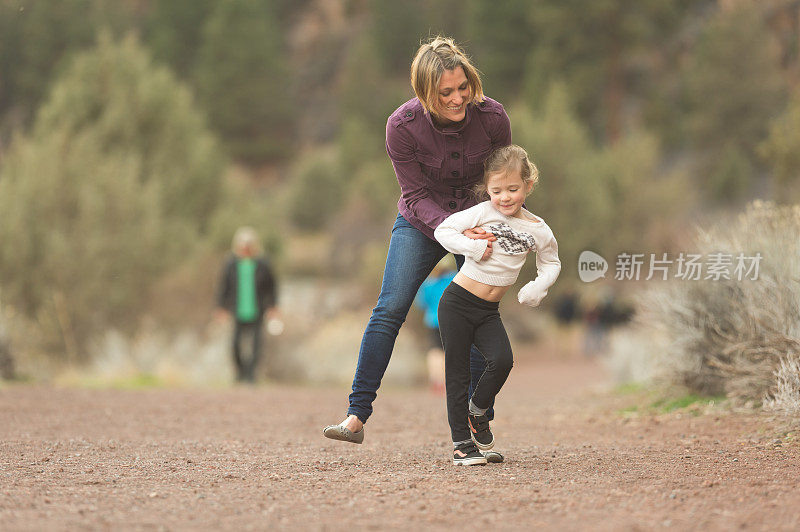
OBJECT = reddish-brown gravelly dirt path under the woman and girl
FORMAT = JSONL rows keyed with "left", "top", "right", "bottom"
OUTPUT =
{"left": 0, "top": 352, "right": 800, "bottom": 530}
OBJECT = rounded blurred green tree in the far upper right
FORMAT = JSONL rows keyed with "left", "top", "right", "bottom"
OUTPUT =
{"left": 682, "top": 3, "right": 788, "bottom": 201}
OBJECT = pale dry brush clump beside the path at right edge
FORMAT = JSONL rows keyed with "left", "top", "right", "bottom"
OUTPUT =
{"left": 640, "top": 202, "right": 800, "bottom": 402}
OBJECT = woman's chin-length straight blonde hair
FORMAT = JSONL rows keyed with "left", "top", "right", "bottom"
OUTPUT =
{"left": 411, "top": 35, "right": 483, "bottom": 114}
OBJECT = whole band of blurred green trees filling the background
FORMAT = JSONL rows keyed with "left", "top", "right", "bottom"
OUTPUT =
{"left": 0, "top": 0, "right": 800, "bottom": 351}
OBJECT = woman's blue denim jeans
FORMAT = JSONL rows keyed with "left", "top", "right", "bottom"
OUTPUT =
{"left": 347, "top": 214, "right": 494, "bottom": 423}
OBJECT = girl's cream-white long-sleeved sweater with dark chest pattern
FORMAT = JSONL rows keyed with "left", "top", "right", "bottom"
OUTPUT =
{"left": 433, "top": 201, "right": 561, "bottom": 307}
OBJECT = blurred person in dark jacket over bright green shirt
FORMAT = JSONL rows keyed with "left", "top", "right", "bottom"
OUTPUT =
{"left": 217, "top": 227, "right": 278, "bottom": 382}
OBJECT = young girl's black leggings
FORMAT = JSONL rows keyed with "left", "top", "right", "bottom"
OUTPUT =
{"left": 439, "top": 283, "right": 514, "bottom": 442}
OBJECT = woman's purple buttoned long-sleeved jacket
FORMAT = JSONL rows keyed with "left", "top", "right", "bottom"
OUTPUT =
{"left": 386, "top": 97, "right": 511, "bottom": 239}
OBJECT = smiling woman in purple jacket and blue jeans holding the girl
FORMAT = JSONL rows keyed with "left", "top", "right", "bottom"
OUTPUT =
{"left": 324, "top": 37, "right": 511, "bottom": 456}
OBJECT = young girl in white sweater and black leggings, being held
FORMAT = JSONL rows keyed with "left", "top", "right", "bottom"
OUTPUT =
{"left": 434, "top": 145, "right": 561, "bottom": 465}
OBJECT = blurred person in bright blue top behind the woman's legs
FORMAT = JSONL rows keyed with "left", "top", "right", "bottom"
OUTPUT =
{"left": 414, "top": 257, "right": 456, "bottom": 394}
